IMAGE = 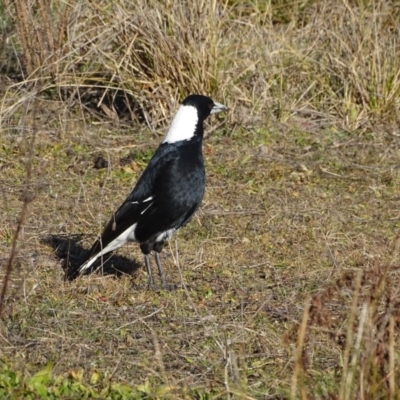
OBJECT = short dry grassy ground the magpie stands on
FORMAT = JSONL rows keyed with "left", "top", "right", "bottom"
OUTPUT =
{"left": 0, "top": 101, "right": 399, "bottom": 398}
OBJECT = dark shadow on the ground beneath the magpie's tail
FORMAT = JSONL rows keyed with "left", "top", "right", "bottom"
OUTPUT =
{"left": 41, "top": 234, "right": 142, "bottom": 280}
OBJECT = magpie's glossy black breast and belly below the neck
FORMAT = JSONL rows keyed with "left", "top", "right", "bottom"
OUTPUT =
{"left": 135, "top": 140, "right": 205, "bottom": 242}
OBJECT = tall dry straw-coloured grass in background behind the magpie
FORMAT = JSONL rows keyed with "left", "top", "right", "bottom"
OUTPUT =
{"left": 3, "top": 0, "right": 400, "bottom": 129}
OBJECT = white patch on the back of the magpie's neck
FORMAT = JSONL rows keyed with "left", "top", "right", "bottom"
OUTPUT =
{"left": 163, "top": 105, "right": 199, "bottom": 143}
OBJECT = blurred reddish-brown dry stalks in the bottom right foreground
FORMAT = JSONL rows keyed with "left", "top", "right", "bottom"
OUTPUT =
{"left": 292, "top": 264, "right": 400, "bottom": 399}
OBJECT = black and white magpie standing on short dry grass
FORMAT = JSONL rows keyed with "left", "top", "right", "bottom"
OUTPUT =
{"left": 69, "top": 94, "right": 227, "bottom": 287}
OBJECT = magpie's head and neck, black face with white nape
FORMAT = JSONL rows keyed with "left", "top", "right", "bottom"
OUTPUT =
{"left": 164, "top": 94, "right": 228, "bottom": 143}
